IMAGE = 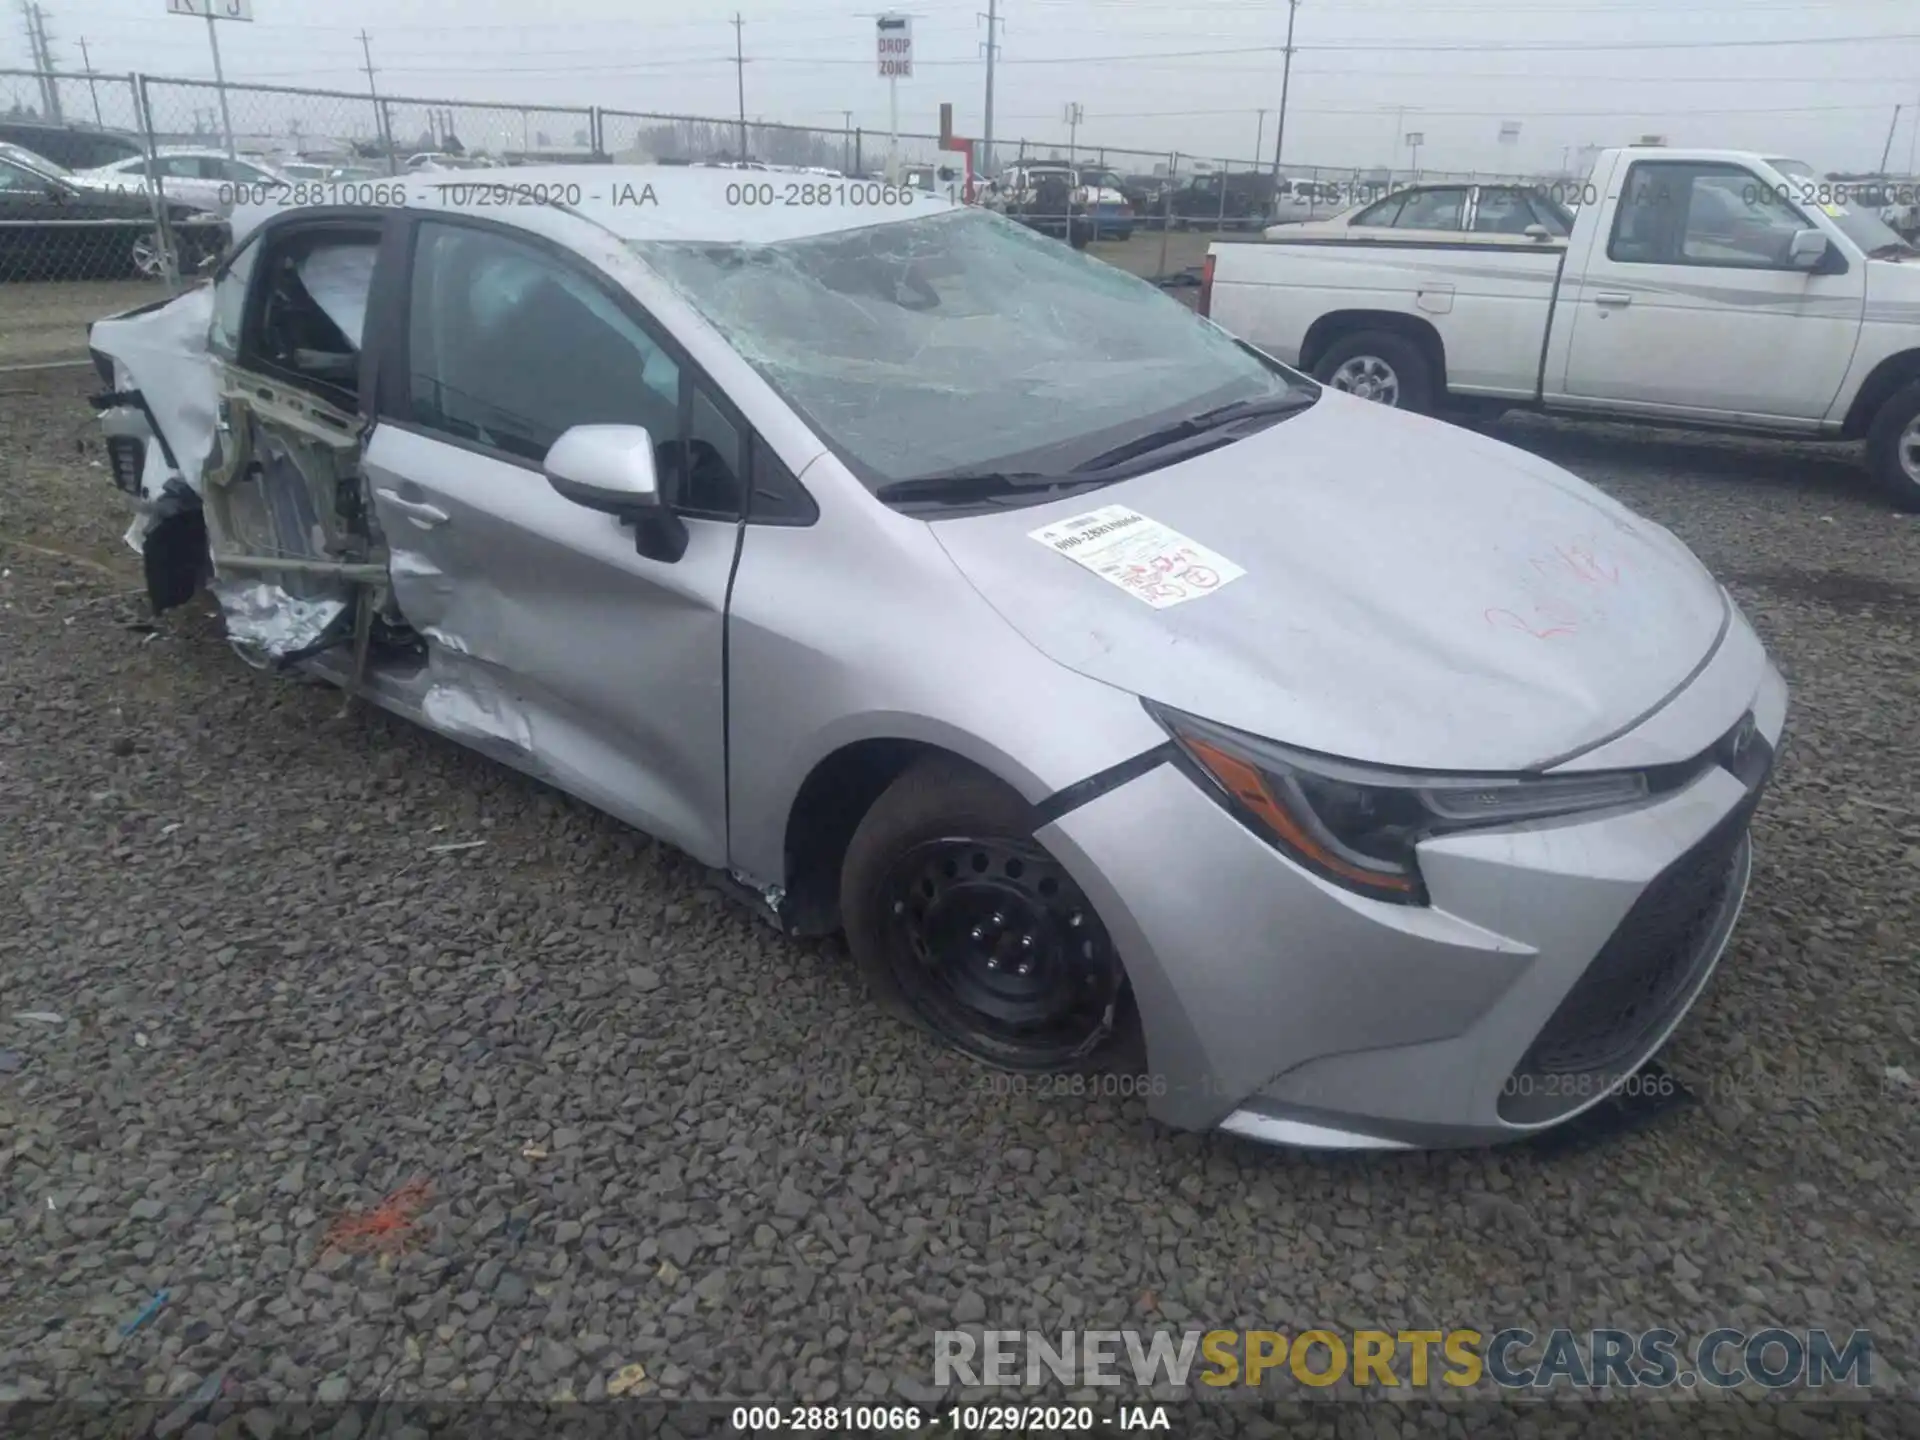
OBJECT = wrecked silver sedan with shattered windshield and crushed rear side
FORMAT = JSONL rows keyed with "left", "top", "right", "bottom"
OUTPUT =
{"left": 92, "top": 167, "right": 1786, "bottom": 1148}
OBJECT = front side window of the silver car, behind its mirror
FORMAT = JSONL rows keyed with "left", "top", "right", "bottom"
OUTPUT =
{"left": 407, "top": 221, "right": 745, "bottom": 518}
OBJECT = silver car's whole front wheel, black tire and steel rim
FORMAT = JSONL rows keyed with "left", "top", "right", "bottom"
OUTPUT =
{"left": 841, "top": 756, "right": 1144, "bottom": 1073}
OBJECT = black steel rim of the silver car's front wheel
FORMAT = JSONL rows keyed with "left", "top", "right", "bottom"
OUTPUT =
{"left": 881, "top": 837, "right": 1125, "bottom": 1069}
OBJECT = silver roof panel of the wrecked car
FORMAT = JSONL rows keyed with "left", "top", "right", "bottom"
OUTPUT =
{"left": 232, "top": 165, "right": 962, "bottom": 244}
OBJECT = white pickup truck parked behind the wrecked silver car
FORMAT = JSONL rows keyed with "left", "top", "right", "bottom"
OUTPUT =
{"left": 1200, "top": 148, "right": 1920, "bottom": 511}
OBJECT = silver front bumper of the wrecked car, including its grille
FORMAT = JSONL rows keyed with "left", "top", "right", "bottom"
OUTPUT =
{"left": 1039, "top": 647, "right": 1786, "bottom": 1148}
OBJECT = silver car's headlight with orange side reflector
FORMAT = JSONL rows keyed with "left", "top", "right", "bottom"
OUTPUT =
{"left": 1146, "top": 701, "right": 1649, "bottom": 904}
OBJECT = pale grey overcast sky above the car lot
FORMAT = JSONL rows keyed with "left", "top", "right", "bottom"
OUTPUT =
{"left": 11, "top": 0, "right": 1920, "bottom": 171}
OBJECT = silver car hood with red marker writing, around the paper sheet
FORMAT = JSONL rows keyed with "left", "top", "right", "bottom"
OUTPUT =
{"left": 933, "top": 392, "right": 1730, "bottom": 772}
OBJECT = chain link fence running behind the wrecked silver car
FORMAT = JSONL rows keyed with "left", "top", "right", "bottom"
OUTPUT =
{"left": 0, "top": 69, "right": 1565, "bottom": 367}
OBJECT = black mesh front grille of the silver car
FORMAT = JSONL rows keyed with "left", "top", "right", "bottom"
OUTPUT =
{"left": 1500, "top": 725, "right": 1772, "bottom": 1123}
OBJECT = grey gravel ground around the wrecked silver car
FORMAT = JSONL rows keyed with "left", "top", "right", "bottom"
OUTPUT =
{"left": 0, "top": 372, "right": 1920, "bottom": 1434}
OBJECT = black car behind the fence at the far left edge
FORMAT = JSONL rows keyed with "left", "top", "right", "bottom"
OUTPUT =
{"left": 0, "top": 146, "right": 227, "bottom": 280}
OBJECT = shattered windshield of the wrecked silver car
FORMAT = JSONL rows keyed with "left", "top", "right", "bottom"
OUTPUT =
{"left": 634, "top": 209, "right": 1308, "bottom": 488}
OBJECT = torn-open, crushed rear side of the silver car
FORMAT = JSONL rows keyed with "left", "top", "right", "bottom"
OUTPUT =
{"left": 90, "top": 221, "right": 417, "bottom": 687}
